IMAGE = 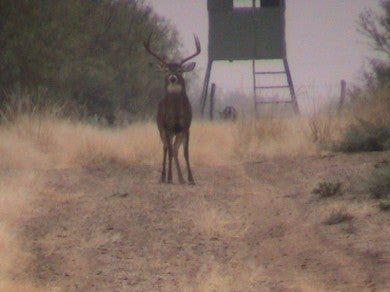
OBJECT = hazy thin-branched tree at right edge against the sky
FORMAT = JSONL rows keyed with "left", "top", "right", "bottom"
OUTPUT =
{"left": 358, "top": 0, "right": 390, "bottom": 87}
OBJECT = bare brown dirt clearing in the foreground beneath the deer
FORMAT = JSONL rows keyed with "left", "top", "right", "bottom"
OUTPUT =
{"left": 9, "top": 152, "right": 390, "bottom": 291}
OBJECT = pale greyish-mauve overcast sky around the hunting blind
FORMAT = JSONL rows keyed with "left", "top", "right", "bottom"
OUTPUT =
{"left": 146, "top": 0, "right": 380, "bottom": 109}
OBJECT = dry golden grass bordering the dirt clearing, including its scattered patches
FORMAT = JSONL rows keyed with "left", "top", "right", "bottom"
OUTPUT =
{"left": 0, "top": 86, "right": 390, "bottom": 291}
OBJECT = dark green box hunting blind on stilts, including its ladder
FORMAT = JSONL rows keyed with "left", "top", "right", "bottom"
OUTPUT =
{"left": 202, "top": 0, "right": 298, "bottom": 115}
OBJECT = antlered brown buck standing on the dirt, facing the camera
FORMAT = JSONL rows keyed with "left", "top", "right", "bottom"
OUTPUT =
{"left": 144, "top": 35, "right": 201, "bottom": 184}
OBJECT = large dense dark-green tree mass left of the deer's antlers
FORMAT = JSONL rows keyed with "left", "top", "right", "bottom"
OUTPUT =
{"left": 0, "top": 0, "right": 183, "bottom": 122}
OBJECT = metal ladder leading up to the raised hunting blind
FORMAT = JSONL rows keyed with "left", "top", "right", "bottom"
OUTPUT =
{"left": 252, "top": 58, "right": 299, "bottom": 116}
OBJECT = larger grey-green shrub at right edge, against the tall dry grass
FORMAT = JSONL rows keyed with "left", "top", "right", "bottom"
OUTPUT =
{"left": 336, "top": 119, "right": 390, "bottom": 152}
